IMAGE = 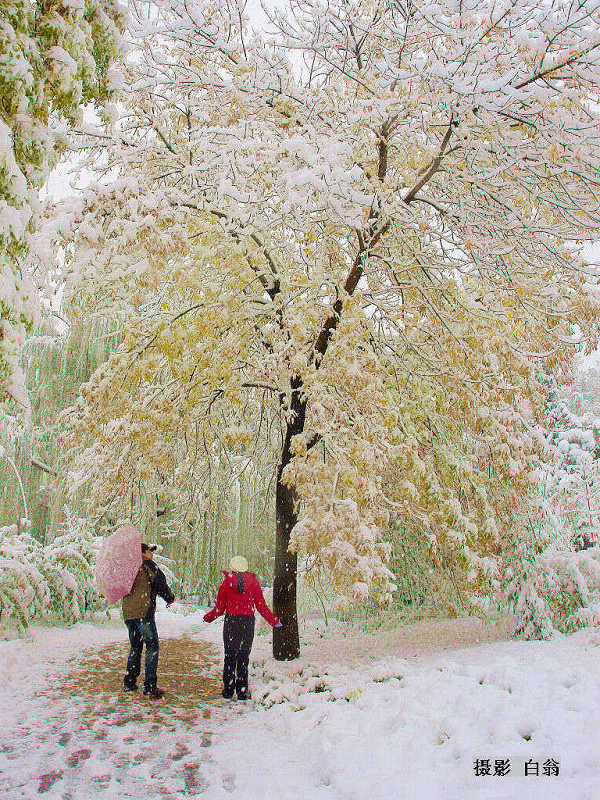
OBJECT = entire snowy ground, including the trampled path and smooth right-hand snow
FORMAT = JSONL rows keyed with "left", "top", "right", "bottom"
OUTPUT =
{"left": 0, "top": 611, "right": 600, "bottom": 800}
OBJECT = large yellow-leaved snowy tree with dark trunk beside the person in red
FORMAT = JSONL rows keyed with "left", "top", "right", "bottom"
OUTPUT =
{"left": 42, "top": 0, "right": 600, "bottom": 658}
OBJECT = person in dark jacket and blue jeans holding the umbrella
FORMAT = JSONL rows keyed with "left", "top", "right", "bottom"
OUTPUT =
{"left": 123, "top": 542, "right": 175, "bottom": 700}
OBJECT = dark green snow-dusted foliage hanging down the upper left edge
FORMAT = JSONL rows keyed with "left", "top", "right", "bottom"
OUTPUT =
{"left": 0, "top": 0, "right": 125, "bottom": 405}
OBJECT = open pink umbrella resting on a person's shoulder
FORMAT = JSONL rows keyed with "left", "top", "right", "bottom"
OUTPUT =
{"left": 96, "top": 523, "right": 142, "bottom": 603}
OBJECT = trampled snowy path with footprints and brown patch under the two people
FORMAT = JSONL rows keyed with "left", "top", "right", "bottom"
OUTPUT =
{"left": 0, "top": 615, "right": 244, "bottom": 800}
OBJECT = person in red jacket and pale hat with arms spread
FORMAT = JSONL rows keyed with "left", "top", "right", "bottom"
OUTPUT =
{"left": 204, "top": 556, "right": 281, "bottom": 700}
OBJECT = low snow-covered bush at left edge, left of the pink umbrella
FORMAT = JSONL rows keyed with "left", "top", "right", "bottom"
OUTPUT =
{"left": 0, "top": 521, "right": 98, "bottom": 630}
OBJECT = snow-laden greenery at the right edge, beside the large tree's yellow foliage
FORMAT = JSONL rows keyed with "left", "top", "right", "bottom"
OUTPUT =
{"left": 501, "top": 373, "right": 600, "bottom": 639}
